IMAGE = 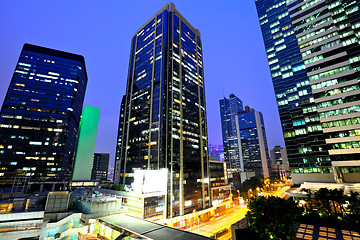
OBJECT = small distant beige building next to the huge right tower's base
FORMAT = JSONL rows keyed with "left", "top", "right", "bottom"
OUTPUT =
{"left": 270, "top": 146, "right": 290, "bottom": 179}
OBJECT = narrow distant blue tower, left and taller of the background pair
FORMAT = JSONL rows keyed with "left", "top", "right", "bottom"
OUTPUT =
{"left": 219, "top": 94, "right": 243, "bottom": 170}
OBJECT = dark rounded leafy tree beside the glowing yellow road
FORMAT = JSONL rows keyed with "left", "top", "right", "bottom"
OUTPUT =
{"left": 246, "top": 196, "right": 303, "bottom": 240}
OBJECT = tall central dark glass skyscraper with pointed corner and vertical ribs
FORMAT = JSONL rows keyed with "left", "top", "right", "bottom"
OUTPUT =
{"left": 114, "top": 3, "right": 210, "bottom": 217}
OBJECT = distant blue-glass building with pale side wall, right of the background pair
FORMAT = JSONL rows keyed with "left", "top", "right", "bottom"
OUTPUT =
{"left": 235, "top": 106, "right": 270, "bottom": 182}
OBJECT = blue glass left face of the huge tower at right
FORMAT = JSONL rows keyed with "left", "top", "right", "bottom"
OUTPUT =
{"left": 255, "top": 0, "right": 332, "bottom": 182}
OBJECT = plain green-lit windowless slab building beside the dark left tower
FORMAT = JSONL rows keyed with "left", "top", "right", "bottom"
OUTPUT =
{"left": 71, "top": 106, "right": 100, "bottom": 181}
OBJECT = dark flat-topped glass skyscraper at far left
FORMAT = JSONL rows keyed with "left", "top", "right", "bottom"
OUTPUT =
{"left": 0, "top": 44, "right": 87, "bottom": 185}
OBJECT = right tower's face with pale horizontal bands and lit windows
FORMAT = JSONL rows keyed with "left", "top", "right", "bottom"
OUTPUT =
{"left": 287, "top": 0, "right": 360, "bottom": 182}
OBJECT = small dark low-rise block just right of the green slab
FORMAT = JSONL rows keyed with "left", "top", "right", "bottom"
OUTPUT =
{"left": 91, "top": 153, "right": 110, "bottom": 181}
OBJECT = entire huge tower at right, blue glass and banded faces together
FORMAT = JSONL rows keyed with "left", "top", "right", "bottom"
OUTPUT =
{"left": 256, "top": 0, "right": 360, "bottom": 183}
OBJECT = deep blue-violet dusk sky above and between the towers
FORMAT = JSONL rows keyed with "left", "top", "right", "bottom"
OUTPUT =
{"left": 0, "top": 0, "right": 284, "bottom": 168}
